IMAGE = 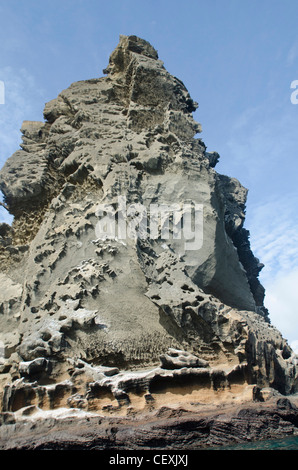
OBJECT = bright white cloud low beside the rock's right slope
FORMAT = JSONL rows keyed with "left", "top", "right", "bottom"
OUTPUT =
{"left": 249, "top": 194, "right": 298, "bottom": 341}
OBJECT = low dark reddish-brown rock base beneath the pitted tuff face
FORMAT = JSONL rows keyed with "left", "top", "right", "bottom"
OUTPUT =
{"left": 0, "top": 394, "right": 298, "bottom": 453}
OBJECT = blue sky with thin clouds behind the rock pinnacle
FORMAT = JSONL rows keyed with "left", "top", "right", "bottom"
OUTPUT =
{"left": 0, "top": 0, "right": 298, "bottom": 350}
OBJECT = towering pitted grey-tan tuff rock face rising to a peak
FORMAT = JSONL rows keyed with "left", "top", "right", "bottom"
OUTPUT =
{"left": 0, "top": 36, "right": 297, "bottom": 430}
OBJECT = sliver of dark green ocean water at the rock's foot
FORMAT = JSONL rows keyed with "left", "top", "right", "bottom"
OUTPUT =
{"left": 212, "top": 436, "right": 298, "bottom": 450}
